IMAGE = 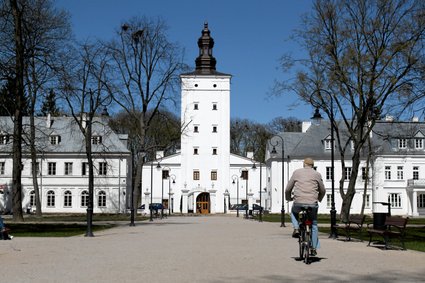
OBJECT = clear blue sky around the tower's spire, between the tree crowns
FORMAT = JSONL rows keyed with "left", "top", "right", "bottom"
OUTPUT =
{"left": 56, "top": 0, "right": 313, "bottom": 123}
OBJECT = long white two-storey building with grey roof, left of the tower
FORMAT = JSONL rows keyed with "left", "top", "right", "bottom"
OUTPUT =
{"left": 0, "top": 116, "right": 131, "bottom": 213}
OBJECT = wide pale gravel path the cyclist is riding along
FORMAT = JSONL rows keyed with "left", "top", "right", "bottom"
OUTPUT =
{"left": 0, "top": 216, "right": 425, "bottom": 283}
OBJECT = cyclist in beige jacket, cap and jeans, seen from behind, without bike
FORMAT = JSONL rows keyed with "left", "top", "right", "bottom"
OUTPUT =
{"left": 285, "top": 158, "right": 326, "bottom": 255}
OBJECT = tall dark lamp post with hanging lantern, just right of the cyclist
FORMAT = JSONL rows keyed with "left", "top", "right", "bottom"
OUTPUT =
{"left": 312, "top": 92, "right": 337, "bottom": 239}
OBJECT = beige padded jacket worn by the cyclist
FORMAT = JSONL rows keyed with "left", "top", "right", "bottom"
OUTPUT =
{"left": 285, "top": 167, "right": 326, "bottom": 204}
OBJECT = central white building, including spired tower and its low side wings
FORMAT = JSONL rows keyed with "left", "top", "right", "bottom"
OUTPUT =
{"left": 142, "top": 24, "right": 266, "bottom": 214}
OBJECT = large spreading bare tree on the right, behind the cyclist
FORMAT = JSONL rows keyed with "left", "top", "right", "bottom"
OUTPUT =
{"left": 281, "top": 0, "right": 425, "bottom": 219}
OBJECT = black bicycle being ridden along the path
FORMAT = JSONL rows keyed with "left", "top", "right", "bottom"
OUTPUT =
{"left": 298, "top": 207, "right": 313, "bottom": 264}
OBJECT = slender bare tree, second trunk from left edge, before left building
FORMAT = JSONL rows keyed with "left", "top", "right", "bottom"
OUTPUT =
{"left": 24, "top": 0, "right": 71, "bottom": 216}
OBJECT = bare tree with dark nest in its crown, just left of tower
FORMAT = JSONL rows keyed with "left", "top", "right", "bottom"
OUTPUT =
{"left": 108, "top": 18, "right": 186, "bottom": 212}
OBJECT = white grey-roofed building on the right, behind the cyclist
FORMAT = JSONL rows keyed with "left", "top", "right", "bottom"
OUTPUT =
{"left": 266, "top": 117, "right": 425, "bottom": 216}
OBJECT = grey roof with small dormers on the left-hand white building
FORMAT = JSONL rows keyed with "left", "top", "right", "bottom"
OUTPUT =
{"left": 0, "top": 116, "right": 129, "bottom": 154}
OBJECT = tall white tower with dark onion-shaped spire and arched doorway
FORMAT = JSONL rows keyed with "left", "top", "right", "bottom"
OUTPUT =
{"left": 180, "top": 23, "right": 231, "bottom": 213}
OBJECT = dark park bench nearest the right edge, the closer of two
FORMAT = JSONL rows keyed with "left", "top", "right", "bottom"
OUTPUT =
{"left": 367, "top": 216, "right": 409, "bottom": 250}
